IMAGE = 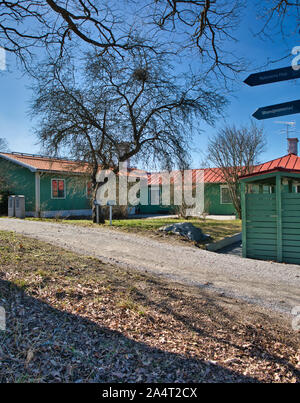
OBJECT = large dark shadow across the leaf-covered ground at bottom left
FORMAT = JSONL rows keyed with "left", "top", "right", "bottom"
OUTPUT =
{"left": 0, "top": 280, "right": 257, "bottom": 383}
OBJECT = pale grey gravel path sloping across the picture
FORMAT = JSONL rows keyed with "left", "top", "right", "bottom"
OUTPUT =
{"left": 0, "top": 218, "right": 300, "bottom": 312}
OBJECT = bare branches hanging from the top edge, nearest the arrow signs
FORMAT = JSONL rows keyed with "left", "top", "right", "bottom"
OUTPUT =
{"left": 150, "top": 0, "right": 246, "bottom": 74}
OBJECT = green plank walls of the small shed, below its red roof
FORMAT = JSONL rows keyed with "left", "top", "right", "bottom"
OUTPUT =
{"left": 242, "top": 173, "right": 300, "bottom": 264}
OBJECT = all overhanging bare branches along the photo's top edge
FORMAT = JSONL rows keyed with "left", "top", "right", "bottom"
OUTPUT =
{"left": 0, "top": 0, "right": 247, "bottom": 78}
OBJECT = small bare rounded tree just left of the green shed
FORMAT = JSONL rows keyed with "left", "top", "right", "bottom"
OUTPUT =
{"left": 208, "top": 122, "right": 266, "bottom": 218}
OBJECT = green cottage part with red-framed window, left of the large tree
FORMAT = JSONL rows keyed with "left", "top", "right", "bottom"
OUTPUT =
{"left": 0, "top": 153, "right": 91, "bottom": 217}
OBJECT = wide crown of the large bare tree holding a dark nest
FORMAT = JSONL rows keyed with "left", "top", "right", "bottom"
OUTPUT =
{"left": 33, "top": 49, "right": 226, "bottom": 224}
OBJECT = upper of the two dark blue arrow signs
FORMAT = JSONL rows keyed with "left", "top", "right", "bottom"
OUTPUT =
{"left": 244, "top": 67, "right": 300, "bottom": 87}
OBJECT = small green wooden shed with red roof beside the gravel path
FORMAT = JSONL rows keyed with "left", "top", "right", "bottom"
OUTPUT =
{"left": 241, "top": 139, "right": 300, "bottom": 264}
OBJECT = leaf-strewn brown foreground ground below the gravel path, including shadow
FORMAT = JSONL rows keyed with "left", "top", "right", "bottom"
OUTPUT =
{"left": 0, "top": 232, "right": 300, "bottom": 382}
